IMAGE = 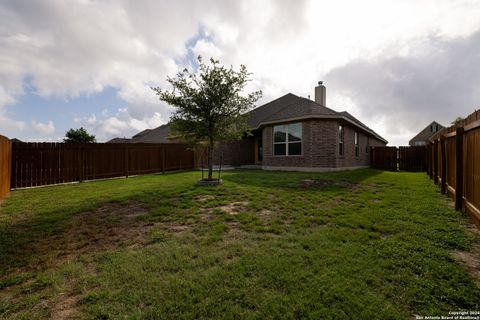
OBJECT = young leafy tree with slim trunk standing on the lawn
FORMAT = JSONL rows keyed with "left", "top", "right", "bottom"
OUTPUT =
{"left": 152, "top": 56, "right": 262, "bottom": 180}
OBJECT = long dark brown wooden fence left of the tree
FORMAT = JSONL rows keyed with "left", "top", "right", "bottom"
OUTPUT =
{"left": 11, "top": 143, "right": 195, "bottom": 188}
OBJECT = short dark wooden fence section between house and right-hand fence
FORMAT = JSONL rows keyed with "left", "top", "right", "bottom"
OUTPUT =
{"left": 370, "top": 146, "right": 427, "bottom": 171}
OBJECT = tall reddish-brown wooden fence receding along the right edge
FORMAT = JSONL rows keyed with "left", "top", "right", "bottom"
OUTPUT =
{"left": 427, "top": 111, "right": 480, "bottom": 228}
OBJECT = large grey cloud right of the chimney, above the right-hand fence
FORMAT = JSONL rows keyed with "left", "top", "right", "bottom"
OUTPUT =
{"left": 326, "top": 32, "right": 480, "bottom": 143}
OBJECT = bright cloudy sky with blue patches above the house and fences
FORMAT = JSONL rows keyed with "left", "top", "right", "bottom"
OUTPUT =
{"left": 0, "top": 0, "right": 480, "bottom": 145}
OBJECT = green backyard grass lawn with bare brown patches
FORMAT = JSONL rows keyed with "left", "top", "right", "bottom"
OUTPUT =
{"left": 0, "top": 169, "right": 480, "bottom": 319}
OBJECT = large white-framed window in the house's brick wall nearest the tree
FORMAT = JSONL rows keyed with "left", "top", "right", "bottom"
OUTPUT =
{"left": 273, "top": 122, "right": 302, "bottom": 156}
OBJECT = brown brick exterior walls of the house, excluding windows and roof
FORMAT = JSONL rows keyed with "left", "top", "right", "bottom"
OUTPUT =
{"left": 201, "top": 119, "right": 385, "bottom": 170}
